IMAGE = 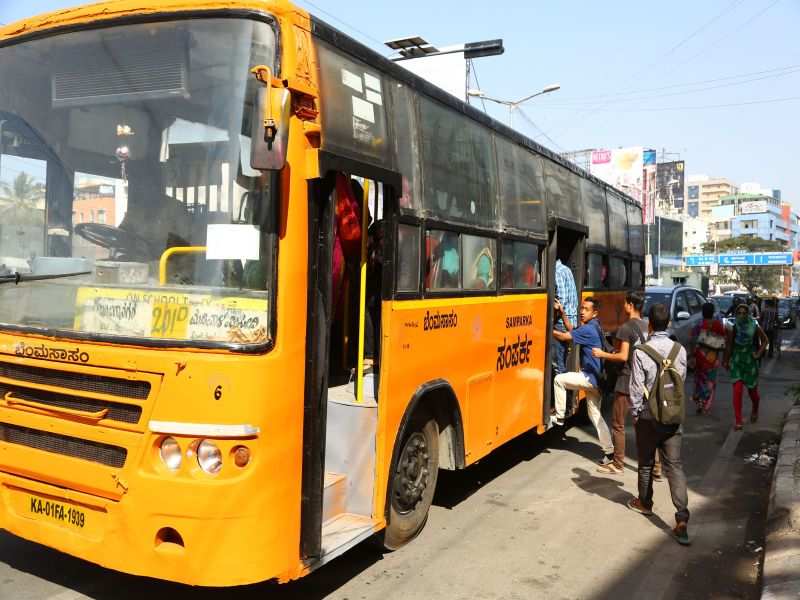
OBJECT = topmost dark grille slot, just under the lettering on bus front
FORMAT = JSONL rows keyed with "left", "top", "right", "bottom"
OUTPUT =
{"left": 0, "top": 361, "right": 150, "bottom": 400}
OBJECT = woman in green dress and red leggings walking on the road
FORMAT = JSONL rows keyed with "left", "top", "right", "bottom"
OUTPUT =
{"left": 724, "top": 304, "right": 768, "bottom": 431}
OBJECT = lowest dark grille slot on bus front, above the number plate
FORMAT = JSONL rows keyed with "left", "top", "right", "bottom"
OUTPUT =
{"left": 0, "top": 423, "right": 128, "bottom": 468}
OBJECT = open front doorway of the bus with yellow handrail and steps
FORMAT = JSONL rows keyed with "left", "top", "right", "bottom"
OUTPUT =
{"left": 301, "top": 171, "right": 391, "bottom": 564}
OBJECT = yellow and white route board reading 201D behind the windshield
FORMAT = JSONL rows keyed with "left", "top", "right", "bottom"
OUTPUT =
{"left": 74, "top": 287, "right": 269, "bottom": 344}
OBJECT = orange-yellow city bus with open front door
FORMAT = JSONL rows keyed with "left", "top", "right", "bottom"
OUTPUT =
{"left": 0, "top": 0, "right": 643, "bottom": 586}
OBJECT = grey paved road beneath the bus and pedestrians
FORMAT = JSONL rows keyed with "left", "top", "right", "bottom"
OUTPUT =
{"left": 0, "top": 332, "right": 800, "bottom": 600}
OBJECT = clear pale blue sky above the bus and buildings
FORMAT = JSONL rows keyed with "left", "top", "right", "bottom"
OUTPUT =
{"left": 0, "top": 0, "right": 800, "bottom": 211}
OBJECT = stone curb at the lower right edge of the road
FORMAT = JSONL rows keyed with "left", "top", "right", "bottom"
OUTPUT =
{"left": 761, "top": 404, "right": 800, "bottom": 600}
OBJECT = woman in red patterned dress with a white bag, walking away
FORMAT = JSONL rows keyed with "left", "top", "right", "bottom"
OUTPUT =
{"left": 692, "top": 302, "right": 725, "bottom": 415}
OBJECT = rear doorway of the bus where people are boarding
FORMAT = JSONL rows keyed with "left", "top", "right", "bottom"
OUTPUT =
{"left": 545, "top": 218, "right": 588, "bottom": 422}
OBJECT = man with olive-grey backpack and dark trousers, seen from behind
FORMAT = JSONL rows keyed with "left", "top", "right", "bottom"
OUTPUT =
{"left": 628, "top": 304, "right": 689, "bottom": 545}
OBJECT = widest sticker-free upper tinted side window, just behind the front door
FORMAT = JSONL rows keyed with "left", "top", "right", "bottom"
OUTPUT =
{"left": 420, "top": 98, "right": 497, "bottom": 228}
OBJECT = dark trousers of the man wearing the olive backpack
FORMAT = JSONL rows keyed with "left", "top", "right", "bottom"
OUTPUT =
{"left": 636, "top": 419, "right": 689, "bottom": 522}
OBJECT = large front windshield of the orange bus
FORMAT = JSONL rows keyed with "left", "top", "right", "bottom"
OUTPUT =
{"left": 0, "top": 19, "right": 277, "bottom": 346}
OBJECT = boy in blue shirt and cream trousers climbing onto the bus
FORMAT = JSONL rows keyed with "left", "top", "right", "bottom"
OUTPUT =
{"left": 553, "top": 296, "right": 614, "bottom": 464}
